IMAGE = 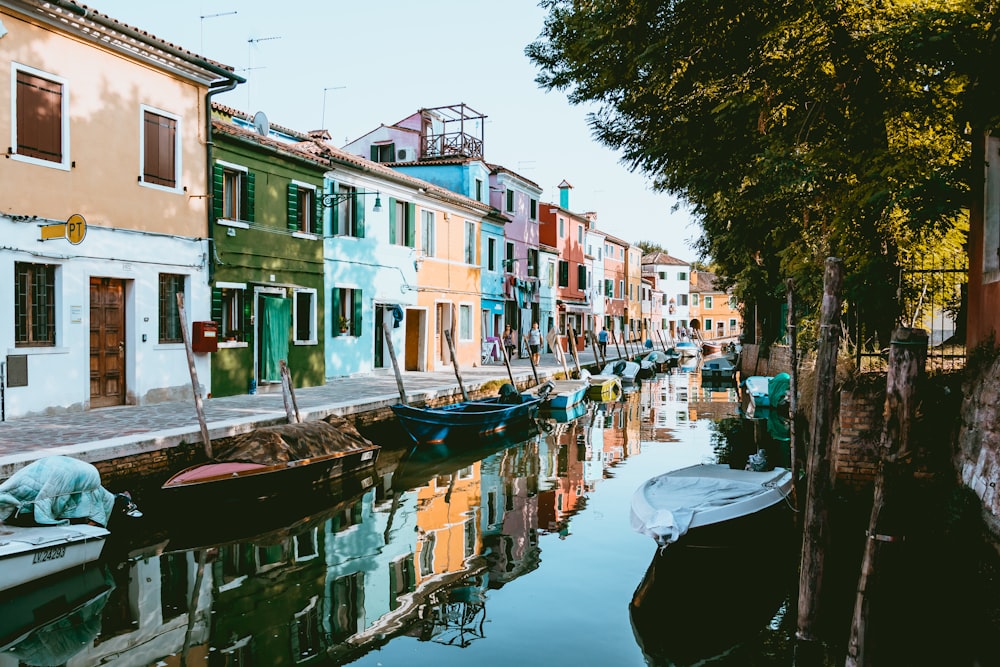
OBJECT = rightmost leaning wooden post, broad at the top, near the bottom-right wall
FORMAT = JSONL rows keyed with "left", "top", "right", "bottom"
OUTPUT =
{"left": 844, "top": 327, "right": 927, "bottom": 667}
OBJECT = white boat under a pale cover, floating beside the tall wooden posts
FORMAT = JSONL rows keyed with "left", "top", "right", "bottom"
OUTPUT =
{"left": 631, "top": 464, "right": 792, "bottom": 547}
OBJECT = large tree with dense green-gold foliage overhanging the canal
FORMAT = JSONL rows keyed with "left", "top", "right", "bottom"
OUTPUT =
{"left": 526, "top": 0, "right": 997, "bottom": 347}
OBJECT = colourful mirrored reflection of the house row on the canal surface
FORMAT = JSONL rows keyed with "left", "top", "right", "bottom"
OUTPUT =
{"left": 25, "top": 389, "right": 712, "bottom": 665}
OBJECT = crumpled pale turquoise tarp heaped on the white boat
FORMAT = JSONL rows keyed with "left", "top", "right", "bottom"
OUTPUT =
{"left": 0, "top": 456, "right": 115, "bottom": 526}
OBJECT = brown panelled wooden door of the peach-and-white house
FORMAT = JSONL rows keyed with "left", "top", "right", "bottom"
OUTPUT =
{"left": 90, "top": 278, "right": 125, "bottom": 408}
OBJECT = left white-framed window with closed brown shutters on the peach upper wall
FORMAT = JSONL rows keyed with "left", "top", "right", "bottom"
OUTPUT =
{"left": 10, "top": 62, "right": 71, "bottom": 171}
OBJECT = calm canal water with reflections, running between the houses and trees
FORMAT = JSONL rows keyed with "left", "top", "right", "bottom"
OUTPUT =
{"left": 7, "top": 369, "right": 992, "bottom": 667}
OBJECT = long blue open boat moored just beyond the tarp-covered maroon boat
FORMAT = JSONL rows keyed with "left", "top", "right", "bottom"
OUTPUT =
{"left": 392, "top": 385, "right": 545, "bottom": 444}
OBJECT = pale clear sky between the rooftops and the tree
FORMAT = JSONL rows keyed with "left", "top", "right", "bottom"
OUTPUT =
{"left": 92, "top": 0, "right": 700, "bottom": 261}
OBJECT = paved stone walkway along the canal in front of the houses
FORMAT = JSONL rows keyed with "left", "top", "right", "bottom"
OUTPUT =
{"left": 0, "top": 350, "right": 594, "bottom": 480}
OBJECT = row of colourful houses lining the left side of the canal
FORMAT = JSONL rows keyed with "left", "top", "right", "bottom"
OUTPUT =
{"left": 0, "top": 0, "right": 740, "bottom": 419}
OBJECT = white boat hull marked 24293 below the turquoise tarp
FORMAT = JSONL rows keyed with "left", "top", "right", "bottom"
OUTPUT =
{"left": 0, "top": 524, "right": 110, "bottom": 591}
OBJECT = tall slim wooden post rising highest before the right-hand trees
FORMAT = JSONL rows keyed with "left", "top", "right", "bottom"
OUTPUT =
{"left": 795, "top": 257, "right": 844, "bottom": 642}
